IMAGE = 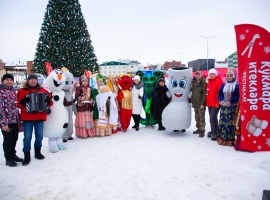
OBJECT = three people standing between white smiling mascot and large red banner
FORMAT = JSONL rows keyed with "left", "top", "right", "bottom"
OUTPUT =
{"left": 191, "top": 68, "right": 239, "bottom": 146}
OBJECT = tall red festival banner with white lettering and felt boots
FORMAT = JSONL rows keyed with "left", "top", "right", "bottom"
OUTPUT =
{"left": 235, "top": 24, "right": 270, "bottom": 151}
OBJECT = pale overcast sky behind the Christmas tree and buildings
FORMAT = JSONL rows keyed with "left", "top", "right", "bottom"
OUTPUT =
{"left": 0, "top": 0, "right": 270, "bottom": 65}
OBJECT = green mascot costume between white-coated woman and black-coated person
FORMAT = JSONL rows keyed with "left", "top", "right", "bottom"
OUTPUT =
{"left": 136, "top": 70, "right": 164, "bottom": 129}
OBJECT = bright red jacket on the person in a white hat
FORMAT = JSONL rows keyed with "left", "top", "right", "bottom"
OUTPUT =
{"left": 206, "top": 76, "right": 223, "bottom": 107}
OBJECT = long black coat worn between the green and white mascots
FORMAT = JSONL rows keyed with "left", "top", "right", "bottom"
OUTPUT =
{"left": 154, "top": 85, "right": 170, "bottom": 120}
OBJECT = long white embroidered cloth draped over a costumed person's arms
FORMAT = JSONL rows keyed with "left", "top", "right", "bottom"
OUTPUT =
{"left": 96, "top": 92, "right": 118, "bottom": 129}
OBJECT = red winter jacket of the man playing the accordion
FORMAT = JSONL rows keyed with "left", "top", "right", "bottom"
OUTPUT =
{"left": 17, "top": 83, "right": 53, "bottom": 121}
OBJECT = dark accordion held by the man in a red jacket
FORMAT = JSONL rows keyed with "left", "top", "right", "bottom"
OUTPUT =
{"left": 26, "top": 92, "right": 49, "bottom": 113}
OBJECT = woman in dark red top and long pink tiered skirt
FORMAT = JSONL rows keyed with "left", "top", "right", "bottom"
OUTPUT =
{"left": 75, "top": 75, "right": 96, "bottom": 139}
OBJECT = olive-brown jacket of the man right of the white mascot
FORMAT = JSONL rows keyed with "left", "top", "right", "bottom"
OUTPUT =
{"left": 191, "top": 78, "right": 207, "bottom": 108}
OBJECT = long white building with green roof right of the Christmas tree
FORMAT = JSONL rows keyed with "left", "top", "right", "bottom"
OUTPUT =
{"left": 99, "top": 61, "right": 144, "bottom": 77}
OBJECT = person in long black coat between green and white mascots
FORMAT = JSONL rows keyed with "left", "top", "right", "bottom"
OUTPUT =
{"left": 154, "top": 78, "right": 171, "bottom": 131}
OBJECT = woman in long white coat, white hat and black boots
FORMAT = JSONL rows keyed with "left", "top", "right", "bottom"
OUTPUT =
{"left": 131, "top": 76, "right": 143, "bottom": 131}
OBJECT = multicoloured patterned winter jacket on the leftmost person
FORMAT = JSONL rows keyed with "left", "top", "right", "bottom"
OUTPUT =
{"left": 0, "top": 84, "right": 19, "bottom": 127}
